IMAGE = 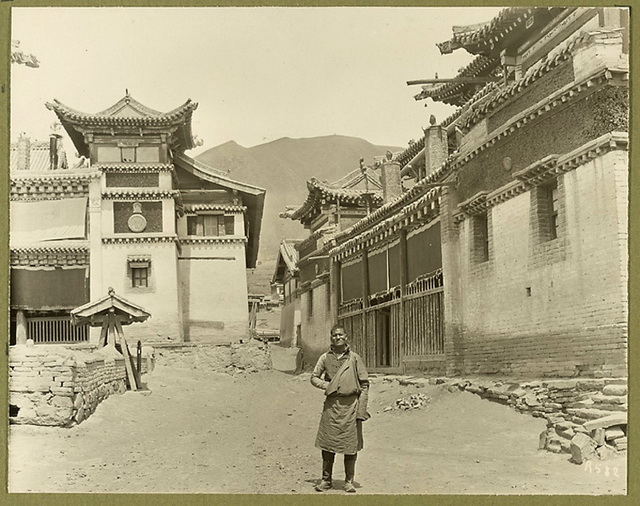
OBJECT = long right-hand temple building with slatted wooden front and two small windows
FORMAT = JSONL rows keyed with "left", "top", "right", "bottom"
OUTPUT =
{"left": 282, "top": 7, "right": 629, "bottom": 377}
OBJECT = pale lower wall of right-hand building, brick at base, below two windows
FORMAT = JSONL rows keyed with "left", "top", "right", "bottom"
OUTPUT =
{"left": 449, "top": 151, "right": 627, "bottom": 377}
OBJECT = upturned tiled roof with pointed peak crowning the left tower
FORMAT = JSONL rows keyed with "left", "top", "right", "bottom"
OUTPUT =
{"left": 45, "top": 93, "right": 198, "bottom": 156}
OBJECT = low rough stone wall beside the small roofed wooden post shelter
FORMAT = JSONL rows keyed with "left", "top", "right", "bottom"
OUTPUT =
{"left": 9, "top": 345, "right": 153, "bottom": 427}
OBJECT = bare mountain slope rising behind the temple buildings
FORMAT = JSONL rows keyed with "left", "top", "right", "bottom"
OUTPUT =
{"left": 196, "top": 135, "right": 401, "bottom": 293}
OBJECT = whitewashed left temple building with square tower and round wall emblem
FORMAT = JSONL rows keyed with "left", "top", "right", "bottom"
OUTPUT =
{"left": 10, "top": 93, "right": 265, "bottom": 343}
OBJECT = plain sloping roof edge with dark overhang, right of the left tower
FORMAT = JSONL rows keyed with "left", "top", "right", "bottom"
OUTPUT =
{"left": 173, "top": 153, "right": 266, "bottom": 268}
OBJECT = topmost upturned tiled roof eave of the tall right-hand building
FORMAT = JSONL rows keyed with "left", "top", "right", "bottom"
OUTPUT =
{"left": 436, "top": 7, "right": 565, "bottom": 57}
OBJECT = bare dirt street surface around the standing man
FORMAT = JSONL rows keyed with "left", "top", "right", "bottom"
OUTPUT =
{"left": 9, "top": 359, "right": 626, "bottom": 495}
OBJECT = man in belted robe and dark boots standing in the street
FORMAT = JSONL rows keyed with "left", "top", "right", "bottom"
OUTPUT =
{"left": 311, "top": 325, "right": 370, "bottom": 492}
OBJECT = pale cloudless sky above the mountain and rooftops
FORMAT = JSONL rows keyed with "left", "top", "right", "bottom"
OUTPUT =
{"left": 11, "top": 7, "right": 500, "bottom": 156}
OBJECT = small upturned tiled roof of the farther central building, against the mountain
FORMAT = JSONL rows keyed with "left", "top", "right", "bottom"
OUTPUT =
{"left": 280, "top": 178, "right": 383, "bottom": 221}
